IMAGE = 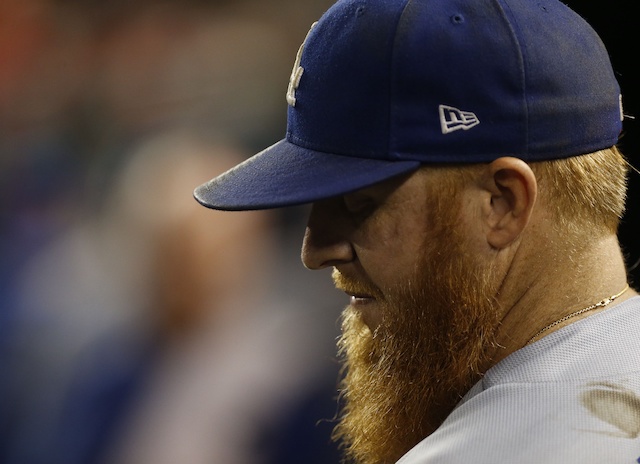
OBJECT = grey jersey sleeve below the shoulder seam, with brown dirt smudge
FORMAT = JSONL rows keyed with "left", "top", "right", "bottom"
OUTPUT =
{"left": 399, "top": 376, "right": 640, "bottom": 464}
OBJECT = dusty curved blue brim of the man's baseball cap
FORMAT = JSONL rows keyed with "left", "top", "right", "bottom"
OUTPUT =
{"left": 194, "top": 140, "right": 420, "bottom": 211}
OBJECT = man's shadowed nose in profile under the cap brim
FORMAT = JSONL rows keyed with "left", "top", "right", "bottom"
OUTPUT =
{"left": 302, "top": 199, "right": 355, "bottom": 270}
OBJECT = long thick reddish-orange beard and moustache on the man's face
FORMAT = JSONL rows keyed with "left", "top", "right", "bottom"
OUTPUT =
{"left": 334, "top": 229, "right": 499, "bottom": 464}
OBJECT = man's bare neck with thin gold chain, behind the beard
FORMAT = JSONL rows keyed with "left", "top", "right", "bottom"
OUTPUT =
{"left": 489, "top": 235, "right": 637, "bottom": 367}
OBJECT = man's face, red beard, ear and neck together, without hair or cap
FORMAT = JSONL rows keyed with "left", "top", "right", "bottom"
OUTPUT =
{"left": 302, "top": 158, "right": 635, "bottom": 463}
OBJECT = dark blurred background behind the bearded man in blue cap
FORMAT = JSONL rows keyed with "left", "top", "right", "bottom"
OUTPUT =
{"left": 0, "top": 0, "right": 640, "bottom": 464}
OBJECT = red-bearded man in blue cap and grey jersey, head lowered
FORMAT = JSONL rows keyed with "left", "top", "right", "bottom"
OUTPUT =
{"left": 195, "top": 0, "right": 640, "bottom": 464}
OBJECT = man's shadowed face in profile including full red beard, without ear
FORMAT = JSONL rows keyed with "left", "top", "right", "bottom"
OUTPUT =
{"left": 303, "top": 170, "right": 498, "bottom": 463}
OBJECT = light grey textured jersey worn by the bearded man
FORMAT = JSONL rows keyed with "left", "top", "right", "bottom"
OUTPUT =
{"left": 398, "top": 296, "right": 640, "bottom": 464}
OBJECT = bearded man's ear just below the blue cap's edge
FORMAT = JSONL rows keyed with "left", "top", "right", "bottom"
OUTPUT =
{"left": 482, "top": 157, "right": 538, "bottom": 249}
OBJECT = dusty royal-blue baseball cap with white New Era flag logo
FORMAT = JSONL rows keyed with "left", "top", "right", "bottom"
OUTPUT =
{"left": 194, "top": 0, "right": 622, "bottom": 210}
